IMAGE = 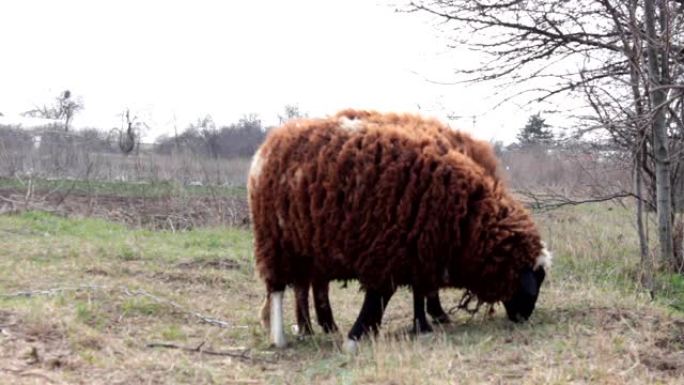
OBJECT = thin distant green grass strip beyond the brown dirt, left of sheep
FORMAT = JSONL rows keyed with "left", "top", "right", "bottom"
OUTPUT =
{"left": 0, "top": 178, "right": 246, "bottom": 198}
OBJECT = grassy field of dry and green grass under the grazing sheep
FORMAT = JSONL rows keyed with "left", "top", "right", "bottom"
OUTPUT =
{"left": 0, "top": 205, "right": 684, "bottom": 385}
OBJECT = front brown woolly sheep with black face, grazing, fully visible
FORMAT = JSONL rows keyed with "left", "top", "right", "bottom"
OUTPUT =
{"left": 248, "top": 110, "right": 546, "bottom": 347}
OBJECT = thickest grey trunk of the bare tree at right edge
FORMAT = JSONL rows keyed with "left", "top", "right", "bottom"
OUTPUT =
{"left": 644, "top": 0, "right": 674, "bottom": 266}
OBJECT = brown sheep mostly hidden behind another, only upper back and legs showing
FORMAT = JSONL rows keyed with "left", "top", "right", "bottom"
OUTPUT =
{"left": 261, "top": 109, "right": 498, "bottom": 334}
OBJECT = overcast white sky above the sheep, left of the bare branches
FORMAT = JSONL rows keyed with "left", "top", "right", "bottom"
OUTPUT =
{"left": 0, "top": 0, "right": 530, "bottom": 142}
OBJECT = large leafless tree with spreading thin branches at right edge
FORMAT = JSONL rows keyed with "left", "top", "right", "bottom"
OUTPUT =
{"left": 409, "top": 0, "right": 684, "bottom": 272}
